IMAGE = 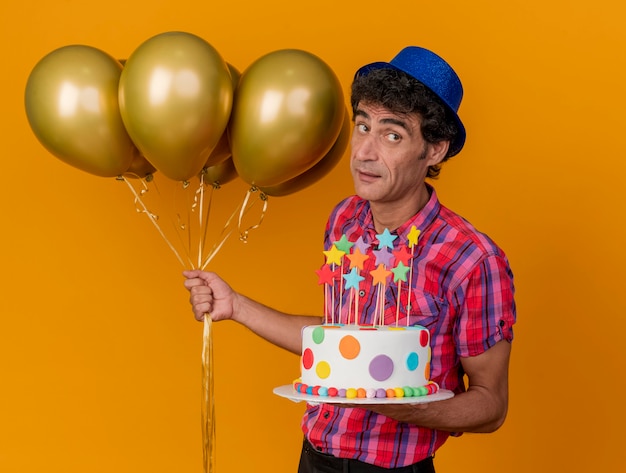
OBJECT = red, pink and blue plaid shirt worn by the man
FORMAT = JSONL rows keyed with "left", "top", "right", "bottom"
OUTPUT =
{"left": 302, "top": 186, "right": 515, "bottom": 468}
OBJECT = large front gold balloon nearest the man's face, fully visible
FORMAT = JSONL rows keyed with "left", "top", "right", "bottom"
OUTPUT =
{"left": 230, "top": 49, "right": 345, "bottom": 186}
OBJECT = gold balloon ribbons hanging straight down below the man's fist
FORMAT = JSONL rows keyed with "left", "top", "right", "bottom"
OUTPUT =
{"left": 201, "top": 314, "right": 216, "bottom": 473}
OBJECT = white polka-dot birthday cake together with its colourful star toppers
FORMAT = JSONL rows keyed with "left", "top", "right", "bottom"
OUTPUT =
{"left": 293, "top": 226, "right": 439, "bottom": 399}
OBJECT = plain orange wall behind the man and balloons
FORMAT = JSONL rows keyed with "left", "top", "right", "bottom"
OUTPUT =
{"left": 0, "top": 0, "right": 626, "bottom": 473}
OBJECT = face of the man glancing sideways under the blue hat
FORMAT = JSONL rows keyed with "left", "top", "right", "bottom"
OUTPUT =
{"left": 350, "top": 103, "right": 440, "bottom": 205}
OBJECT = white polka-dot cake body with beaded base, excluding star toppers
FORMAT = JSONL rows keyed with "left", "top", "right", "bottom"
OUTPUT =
{"left": 294, "top": 324, "right": 437, "bottom": 398}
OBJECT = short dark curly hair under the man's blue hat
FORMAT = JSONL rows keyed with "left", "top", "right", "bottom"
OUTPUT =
{"left": 351, "top": 68, "right": 458, "bottom": 179}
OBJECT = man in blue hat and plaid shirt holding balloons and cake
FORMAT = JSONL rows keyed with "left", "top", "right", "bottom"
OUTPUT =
{"left": 184, "top": 47, "right": 515, "bottom": 473}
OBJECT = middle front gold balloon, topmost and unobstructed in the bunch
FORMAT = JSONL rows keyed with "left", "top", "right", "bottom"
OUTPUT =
{"left": 119, "top": 32, "right": 233, "bottom": 181}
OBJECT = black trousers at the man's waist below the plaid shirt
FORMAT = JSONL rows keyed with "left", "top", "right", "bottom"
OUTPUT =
{"left": 298, "top": 439, "right": 435, "bottom": 473}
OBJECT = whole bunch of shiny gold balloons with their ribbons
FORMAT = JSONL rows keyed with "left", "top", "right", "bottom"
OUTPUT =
{"left": 25, "top": 32, "right": 350, "bottom": 472}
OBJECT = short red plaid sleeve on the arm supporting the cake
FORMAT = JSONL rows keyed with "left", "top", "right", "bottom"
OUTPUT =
{"left": 454, "top": 255, "right": 516, "bottom": 357}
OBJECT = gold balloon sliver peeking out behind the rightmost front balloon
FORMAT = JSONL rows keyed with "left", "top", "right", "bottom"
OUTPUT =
{"left": 260, "top": 110, "right": 352, "bottom": 197}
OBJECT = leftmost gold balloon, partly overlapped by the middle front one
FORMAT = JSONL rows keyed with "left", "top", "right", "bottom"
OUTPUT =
{"left": 25, "top": 45, "right": 134, "bottom": 177}
